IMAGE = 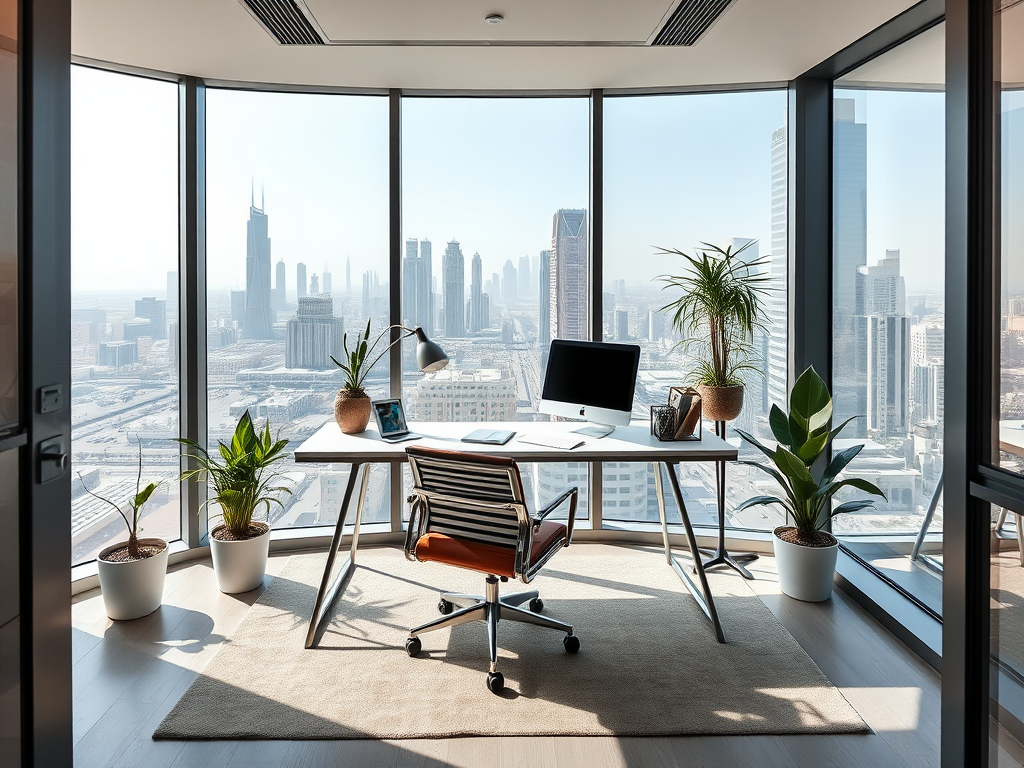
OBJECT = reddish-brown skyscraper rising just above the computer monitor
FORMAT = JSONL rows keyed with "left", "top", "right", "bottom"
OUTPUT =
{"left": 549, "top": 208, "right": 590, "bottom": 340}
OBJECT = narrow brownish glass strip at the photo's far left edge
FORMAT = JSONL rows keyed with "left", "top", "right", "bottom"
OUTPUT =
{"left": 0, "top": 0, "right": 18, "bottom": 433}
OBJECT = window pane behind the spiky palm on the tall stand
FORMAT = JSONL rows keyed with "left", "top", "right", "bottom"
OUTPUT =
{"left": 602, "top": 91, "right": 787, "bottom": 529}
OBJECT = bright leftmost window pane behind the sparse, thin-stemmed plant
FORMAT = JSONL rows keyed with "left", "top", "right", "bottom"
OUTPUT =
{"left": 71, "top": 67, "right": 181, "bottom": 564}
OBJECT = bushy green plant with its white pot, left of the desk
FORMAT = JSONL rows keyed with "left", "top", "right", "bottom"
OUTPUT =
{"left": 175, "top": 411, "right": 292, "bottom": 594}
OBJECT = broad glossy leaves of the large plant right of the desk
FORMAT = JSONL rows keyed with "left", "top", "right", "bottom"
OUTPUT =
{"left": 736, "top": 367, "right": 886, "bottom": 544}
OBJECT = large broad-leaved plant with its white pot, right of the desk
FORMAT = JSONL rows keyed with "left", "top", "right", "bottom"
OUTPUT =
{"left": 736, "top": 367, "right": 885, "bottom": 602}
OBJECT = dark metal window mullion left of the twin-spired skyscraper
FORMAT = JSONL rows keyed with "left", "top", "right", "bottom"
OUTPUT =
{"left": 177, "top": 77, "right": 208, "bottom": 547}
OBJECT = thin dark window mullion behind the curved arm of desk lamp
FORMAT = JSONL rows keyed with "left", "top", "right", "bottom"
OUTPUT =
{"left": 388, "top": 88, "right": 401, "bottom": 531}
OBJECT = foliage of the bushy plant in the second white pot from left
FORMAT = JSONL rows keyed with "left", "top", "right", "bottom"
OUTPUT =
{"left": 175, "top": 411, "right": 292, "bottom": 539}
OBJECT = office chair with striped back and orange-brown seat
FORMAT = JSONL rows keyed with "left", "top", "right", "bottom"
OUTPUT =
{"left": 406, "top": 447, "right": 580, "bottom": 693}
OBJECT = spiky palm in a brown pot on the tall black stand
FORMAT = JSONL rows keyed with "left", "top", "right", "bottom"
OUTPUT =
{"left": 658, "top": 241, "right": 769, "bottom": 421}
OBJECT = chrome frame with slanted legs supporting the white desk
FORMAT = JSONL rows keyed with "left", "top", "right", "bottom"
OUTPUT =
{"left": 296, "top": 423, "right": 726, "bottom": 648}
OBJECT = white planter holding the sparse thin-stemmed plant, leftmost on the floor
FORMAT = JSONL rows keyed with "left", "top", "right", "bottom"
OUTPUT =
{"left": 96, "top": 539, "right": 168, "bottom": 622}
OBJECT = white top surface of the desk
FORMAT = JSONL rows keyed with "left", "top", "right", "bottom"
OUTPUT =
{"left": 295, "top": 420, "right": 736, "bottom": 463}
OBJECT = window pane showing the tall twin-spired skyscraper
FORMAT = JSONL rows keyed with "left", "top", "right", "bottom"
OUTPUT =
{"left": 207, "top": 89, "right": 390, "bottom": 528}
